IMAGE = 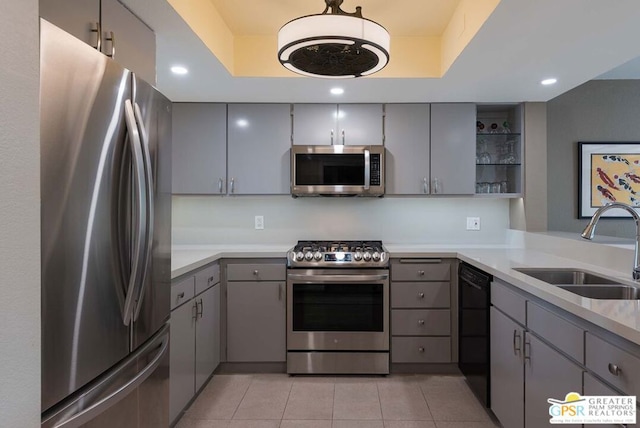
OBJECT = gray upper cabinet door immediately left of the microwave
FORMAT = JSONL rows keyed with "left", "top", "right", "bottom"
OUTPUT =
{"left": 227, "top": 104, "right": 291, "bottom": 195}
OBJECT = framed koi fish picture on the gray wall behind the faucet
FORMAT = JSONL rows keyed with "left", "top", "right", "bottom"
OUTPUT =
{"left": 578, "top": 142, "right": 640, "bottom": 219}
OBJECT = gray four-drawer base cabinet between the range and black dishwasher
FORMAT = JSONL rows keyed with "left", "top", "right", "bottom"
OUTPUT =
{"left": 391, "top": 259, "right": 452, "bottom": 363}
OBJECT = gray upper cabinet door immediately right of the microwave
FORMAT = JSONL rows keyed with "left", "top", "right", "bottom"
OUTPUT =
{"left": 385, "top": 104, "right": 430, "bottom": 195}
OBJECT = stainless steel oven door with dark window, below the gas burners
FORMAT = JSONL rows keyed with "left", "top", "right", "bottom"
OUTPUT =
{"left": 287, "top": 269, "right": 389, "bottom": 351}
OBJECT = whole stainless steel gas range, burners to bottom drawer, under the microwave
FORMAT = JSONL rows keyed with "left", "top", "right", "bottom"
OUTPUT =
{"left": 287, "top": 241, "right": 389, "bottom": 374}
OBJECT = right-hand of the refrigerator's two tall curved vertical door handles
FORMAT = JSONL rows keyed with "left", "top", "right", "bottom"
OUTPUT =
{"left": 133, "top": 103, "right": 154, "bottom": 321}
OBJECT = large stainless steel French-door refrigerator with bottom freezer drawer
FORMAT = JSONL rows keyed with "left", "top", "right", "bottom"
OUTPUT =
{"left": 40, "top": 20, "right": 171, "bottom": 428}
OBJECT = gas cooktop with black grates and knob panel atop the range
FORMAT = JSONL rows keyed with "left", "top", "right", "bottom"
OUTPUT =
{"left": 287, "top": 241, "right": 389, "bottom": 268}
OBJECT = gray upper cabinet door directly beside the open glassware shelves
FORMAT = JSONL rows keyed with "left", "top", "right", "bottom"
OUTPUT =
{"left": 431, "top": 103, "right": 476, "bottom": 195}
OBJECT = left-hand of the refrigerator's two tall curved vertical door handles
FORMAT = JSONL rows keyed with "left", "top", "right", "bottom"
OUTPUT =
{"left": 122, "top": 100, "right": 147, "bottom": 325}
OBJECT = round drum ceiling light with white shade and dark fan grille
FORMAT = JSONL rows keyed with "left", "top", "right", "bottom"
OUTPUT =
{"left": 278, "top": 0, "right": 390, "bottom": 79}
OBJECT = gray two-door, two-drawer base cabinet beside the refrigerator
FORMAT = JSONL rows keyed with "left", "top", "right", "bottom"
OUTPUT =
{"left": 169, "top": 264, "right": 220, "bottom": 422}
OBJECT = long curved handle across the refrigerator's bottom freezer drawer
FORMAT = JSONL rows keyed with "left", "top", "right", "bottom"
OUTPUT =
{"left": 42, "top": 326, "right": 169, "bottom": 428}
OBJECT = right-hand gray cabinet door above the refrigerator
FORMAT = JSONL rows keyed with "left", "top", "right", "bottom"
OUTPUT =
{"left": 100, "top": 0, "right": 156, "bottom": 85}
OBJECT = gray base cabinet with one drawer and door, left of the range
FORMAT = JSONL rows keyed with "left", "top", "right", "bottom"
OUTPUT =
{"left": 227, "top": 260, "right": 287, "bottom": 363}
